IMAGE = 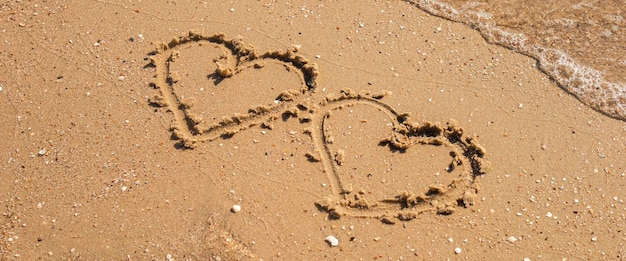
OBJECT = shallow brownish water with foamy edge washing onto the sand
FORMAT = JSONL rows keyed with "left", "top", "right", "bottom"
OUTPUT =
{"left": 407, "top": 0, "right": 626, "bottom": 120}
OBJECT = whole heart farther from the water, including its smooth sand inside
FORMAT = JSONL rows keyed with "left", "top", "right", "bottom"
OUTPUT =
{"left": 151, "top": 32, "right": 318, "bottom": 147}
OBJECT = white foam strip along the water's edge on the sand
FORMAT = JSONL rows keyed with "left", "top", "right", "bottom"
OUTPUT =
{"left": 407, "top": 0, "right": 626, "bottom": 120}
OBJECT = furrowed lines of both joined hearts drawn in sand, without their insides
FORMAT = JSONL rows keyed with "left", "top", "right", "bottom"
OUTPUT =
{"left": 150, "top": 32, "right": 488, "bottom": 221}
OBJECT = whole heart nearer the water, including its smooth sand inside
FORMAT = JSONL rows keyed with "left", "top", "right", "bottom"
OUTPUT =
{"left": 311, "top": 90, "right": 487, "bottom": 223}
